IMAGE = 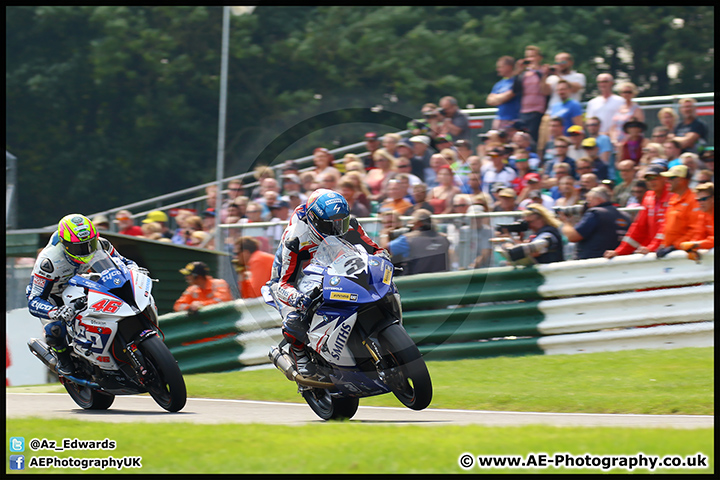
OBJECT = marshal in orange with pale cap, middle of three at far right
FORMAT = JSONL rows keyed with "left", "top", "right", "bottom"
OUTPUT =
{"left": 657, "top": 165, "right": 701, "bottom": 258}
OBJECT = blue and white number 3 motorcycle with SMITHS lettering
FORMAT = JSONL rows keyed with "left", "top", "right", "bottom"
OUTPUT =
{"left": 263, "top": 237, "right": 432, "bottom": 420}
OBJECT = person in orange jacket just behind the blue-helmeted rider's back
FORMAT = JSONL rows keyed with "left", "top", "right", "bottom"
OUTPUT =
{"left": 233, "top": 237, "right": 275, "bottom": 298}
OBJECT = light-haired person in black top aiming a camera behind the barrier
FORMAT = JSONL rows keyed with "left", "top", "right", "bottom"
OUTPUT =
{"left": 498, "top": 203, "right": 565, "bottom": 265}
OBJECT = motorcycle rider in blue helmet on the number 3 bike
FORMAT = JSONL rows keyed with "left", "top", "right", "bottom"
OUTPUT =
{"left": 271, "top": 189, "right": 390, "bottom": 376}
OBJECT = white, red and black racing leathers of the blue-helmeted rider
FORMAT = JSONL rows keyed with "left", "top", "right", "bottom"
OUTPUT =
{"left": 271, "top": 205, "right": 390, "bottom": 348}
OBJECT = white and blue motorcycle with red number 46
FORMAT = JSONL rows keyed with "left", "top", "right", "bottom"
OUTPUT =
{"left": 28, "top": 250, "right": 187, "bottom": 412}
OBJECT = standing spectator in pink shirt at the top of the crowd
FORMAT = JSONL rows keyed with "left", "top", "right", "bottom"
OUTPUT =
{"left": 515, "top": 45, "right": 551, "bottom": 142}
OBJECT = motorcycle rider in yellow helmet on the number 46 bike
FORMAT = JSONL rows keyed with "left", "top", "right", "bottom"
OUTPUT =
{"left": 25, "top": 213, "right": 147, "bottom": 376}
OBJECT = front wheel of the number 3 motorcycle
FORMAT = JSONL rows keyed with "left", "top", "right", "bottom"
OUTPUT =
{"left": 378, "top": 324, "right": 432, "bottom": 410}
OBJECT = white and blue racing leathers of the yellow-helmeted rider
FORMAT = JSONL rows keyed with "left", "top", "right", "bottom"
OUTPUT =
{"left": 25, "top": 232, "right": 139, "bottom": 375}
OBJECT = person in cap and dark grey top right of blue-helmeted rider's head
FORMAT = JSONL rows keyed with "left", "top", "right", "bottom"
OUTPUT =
{"left": 389, "top": 209, "right": 450, "bottom": 275}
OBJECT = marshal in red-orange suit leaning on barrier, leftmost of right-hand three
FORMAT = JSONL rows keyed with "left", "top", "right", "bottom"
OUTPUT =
{"left": 603, "top": 165, "right": 672, "bottom": 259}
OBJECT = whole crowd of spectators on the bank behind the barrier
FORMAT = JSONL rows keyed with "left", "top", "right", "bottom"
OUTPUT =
{"left": 98, "top": 45, "right": 714, "bottom": 296}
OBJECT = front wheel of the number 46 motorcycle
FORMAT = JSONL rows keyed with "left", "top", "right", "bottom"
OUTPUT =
{"left": 138, "top": 336, "right": 187, "bottom": 412}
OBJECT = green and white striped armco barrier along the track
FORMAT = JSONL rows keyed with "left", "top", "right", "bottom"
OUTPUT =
{"left": 160, "top": 250, "right": 715, "bottom": 373}
